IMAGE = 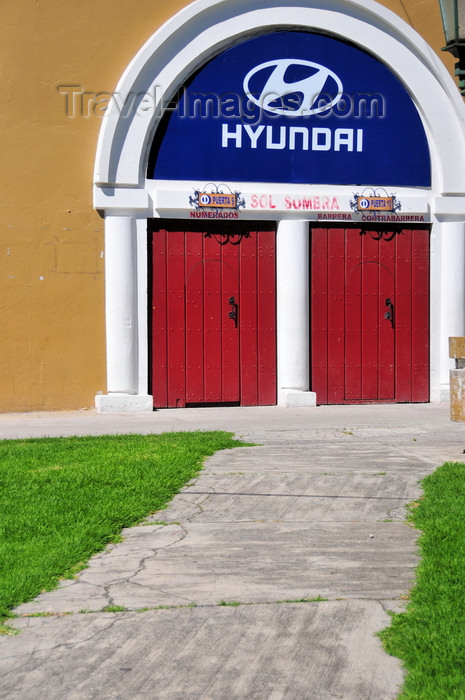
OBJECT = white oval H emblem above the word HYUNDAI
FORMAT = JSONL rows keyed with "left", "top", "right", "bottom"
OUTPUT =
{"left": 244, "top": 58, "right": 343, "bottom": 116}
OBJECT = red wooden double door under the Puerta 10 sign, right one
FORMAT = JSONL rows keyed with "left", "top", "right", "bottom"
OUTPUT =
{"left": 311, "top": 226, "right": 429, "bottom": 404}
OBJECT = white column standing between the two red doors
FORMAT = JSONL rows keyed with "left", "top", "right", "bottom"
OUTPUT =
{"left": 276, "top": 220, "right": 316, "bottom": 406}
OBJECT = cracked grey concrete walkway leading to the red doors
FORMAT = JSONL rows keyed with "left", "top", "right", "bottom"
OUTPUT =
{"left": 0, "top": 404, "right": 465, "bottom": 700}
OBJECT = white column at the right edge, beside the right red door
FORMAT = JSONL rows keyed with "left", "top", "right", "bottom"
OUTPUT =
{"left": 430, "top": 221, "right": 465, "bottom": 401}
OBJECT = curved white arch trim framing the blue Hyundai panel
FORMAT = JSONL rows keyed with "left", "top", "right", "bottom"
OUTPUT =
{"left": 94, "top": 0, "right": 465, "bottom": 197}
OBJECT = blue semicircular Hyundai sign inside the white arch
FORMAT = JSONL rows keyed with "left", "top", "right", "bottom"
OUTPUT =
{"left": 148, "top": 31, "right": 431, "bottom": 187}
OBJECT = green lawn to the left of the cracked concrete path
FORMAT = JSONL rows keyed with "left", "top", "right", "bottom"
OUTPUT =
{"left": 0, "top": 432, "right": 248, "bottom": 621}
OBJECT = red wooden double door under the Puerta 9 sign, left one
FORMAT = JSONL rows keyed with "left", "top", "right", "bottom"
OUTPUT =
{"left": 151, "top": 221, "right": 276, "bottom": 408}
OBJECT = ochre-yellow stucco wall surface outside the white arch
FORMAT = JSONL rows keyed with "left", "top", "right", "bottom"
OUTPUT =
{"left": 0, "top": 0, "right": 454, "bottom": 411}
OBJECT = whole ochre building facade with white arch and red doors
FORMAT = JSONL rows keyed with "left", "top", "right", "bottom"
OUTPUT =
{"left": 1, "top": 0, "right": 465, "bottom": 411}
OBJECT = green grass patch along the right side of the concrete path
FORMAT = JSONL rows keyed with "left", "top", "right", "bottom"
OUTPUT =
{"left": 381, "top": 463, "right": 465, "bottom": 700}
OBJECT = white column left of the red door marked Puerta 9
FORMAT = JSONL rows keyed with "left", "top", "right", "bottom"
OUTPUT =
{"left": 96, "top": 216, "right": 152, "bottom": 413}
